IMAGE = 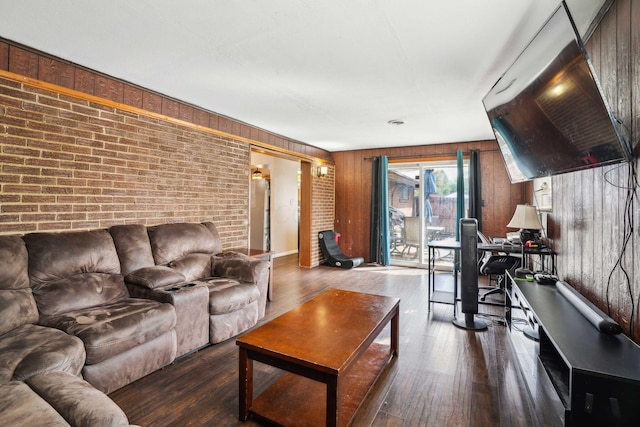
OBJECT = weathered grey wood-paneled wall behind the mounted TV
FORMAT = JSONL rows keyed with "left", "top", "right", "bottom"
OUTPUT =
{"left": 548, "top": 0, "right": 640, "bottom": 343}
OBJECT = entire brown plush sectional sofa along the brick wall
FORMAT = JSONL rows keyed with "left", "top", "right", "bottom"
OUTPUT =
{"left": 0, "top": 223, "right": 270, "bottom": 426}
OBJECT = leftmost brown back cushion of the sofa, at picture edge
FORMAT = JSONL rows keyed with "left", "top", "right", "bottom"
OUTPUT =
{"left": 0, "top": 236, "right": 38, "bottom": 335}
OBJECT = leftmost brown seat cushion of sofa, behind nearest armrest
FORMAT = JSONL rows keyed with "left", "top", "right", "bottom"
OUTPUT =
{"left": 0, "top": 324, "right": 85, "bottom": 383}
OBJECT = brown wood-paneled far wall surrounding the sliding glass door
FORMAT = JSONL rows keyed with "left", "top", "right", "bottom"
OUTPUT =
{"left": 333, "top": 141, "right": 526, "bottom": 259}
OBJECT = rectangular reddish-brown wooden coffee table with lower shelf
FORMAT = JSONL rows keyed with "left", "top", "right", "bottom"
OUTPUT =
{"left": 236, "top": 289, "right": 400, "bottom": 427}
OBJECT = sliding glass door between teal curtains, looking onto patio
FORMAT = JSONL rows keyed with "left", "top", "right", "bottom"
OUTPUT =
{"left": 388, "top": 159, "right": 468, "bottom": 266}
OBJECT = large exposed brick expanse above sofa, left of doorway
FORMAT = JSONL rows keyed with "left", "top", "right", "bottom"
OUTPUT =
{"left": 0, "top": 78, "right": 250, "bottom": 248}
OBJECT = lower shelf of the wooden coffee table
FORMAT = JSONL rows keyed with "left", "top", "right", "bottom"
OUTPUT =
{"left": 249, "top": 343, "right": 393, "bottom": 427}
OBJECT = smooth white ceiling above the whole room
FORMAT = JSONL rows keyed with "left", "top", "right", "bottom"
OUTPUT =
{"left": 0, "top": 0, "right": 605, "bottom": 151}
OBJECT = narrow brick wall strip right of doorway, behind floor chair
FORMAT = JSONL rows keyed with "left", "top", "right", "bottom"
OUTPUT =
{"left": 311, "top": 166, "right": 335, "bottom": 267}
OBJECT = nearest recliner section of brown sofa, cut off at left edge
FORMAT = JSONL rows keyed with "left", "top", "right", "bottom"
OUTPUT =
{"left": 0, "top": 236, "right": 129, "bottom": 427}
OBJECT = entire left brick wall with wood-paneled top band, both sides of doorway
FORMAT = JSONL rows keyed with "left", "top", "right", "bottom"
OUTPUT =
{"left": 0, "top": 38, "right": 335, "bottom": 266}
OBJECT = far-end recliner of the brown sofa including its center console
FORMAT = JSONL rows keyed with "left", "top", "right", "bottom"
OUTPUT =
{"left": 109, "top": 222, "right": 270, "bottom": 355}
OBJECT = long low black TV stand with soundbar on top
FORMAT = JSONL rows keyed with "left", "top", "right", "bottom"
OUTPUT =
{"left": 507, "top": 273, "right": 640, "bottom": 426}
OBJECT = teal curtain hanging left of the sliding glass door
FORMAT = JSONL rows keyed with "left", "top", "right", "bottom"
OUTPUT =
{"left": 369, "top": 156, "right": 391, "bottom": 265}
